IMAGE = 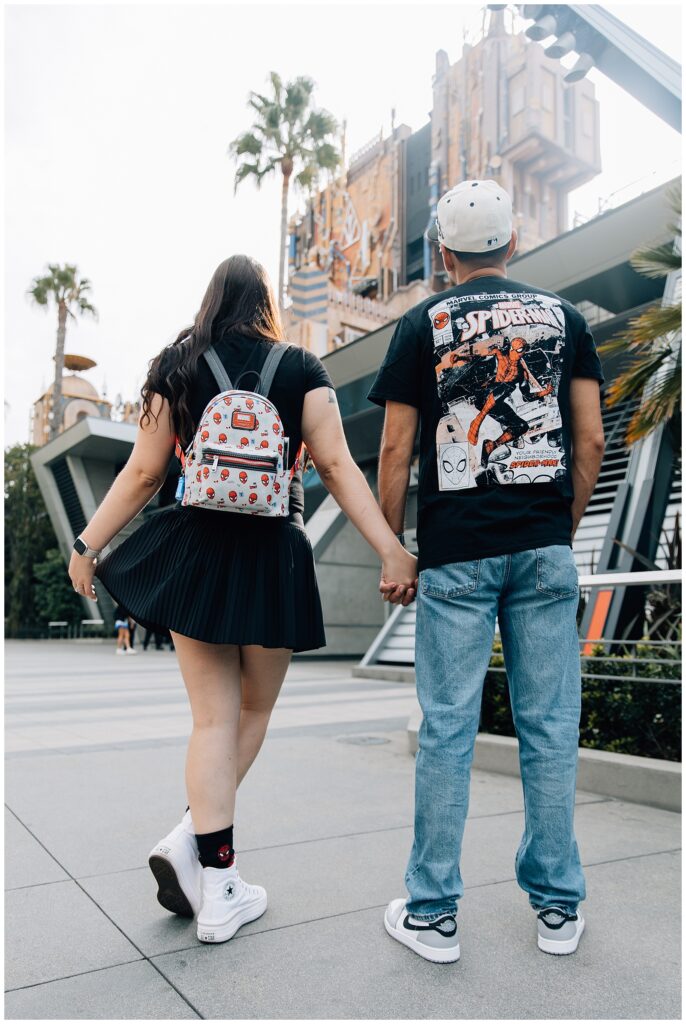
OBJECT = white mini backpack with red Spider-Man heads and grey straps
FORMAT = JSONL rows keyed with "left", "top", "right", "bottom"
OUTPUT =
{"left": 176, "top": 343, "right": 300, "bottom": 516}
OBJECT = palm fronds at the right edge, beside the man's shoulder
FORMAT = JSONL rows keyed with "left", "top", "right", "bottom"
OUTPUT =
{"left": 599, "top": 188, "right": 681, "bottom": 444}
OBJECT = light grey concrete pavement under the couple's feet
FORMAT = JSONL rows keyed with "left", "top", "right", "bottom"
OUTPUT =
{"left": 5, "top": 641, "right": 681, "bottom": 1020}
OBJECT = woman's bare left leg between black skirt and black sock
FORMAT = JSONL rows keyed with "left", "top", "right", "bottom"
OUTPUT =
{"left": 172, "top": 633, "right": 241, "bottom": 835}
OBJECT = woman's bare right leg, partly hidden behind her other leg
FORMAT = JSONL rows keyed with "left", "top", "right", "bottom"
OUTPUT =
{"left": 238, "top": 644, "right": 293, "bottom": 784}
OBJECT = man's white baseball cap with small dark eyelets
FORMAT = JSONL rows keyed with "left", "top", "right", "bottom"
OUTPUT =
{"left": 427, "top": 180, "right": 512, "bottom": 253}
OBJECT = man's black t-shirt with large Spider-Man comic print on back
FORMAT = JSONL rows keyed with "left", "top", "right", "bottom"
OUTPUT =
{"left": 369, "top": 275, "right": 603, "bottom": 568}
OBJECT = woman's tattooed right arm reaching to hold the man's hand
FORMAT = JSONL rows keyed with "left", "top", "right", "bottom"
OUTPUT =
{"left": 302, "top": 387, "right": 417, "bottom": 605}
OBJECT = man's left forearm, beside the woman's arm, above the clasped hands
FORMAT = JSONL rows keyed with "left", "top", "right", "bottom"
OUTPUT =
{"left": 379, "top": 401, "right": 419, "bottom": 534}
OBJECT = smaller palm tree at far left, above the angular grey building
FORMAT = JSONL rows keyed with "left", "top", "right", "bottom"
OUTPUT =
{"left": 29, "top": 263, "right": 97, "bottom": 440}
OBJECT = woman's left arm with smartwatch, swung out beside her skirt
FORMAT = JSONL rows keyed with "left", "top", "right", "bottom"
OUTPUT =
{"left": 69, "top": 395, "right": 175, "bottom": 600}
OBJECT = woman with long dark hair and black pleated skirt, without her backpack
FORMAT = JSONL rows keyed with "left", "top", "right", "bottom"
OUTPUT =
{"left": 69, "top": 256, "right": 417, "bottom": 942}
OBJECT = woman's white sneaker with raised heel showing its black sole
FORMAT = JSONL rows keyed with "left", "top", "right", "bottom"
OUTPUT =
{"left": 147, "top": 811, "right": 203, "bottom": 918}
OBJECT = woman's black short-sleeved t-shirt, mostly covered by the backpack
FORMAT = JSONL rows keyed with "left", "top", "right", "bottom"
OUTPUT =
{"left": 156, "top": 334, "right": 334, "bottom": 514}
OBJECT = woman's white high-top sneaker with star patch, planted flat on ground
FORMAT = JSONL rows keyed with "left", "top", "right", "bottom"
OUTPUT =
{"left": 198, "top": 861, "right": 267, "bottom": 942}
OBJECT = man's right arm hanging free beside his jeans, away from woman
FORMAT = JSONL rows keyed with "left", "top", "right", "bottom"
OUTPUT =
{"left": 569, "top": 377, "right": 605, "bottom": 537}
